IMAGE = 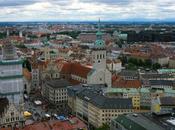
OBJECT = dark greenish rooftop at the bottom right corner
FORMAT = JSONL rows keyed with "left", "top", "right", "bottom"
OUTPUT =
{"left": 115, "top": 113, "right": 170, "bottom": 130}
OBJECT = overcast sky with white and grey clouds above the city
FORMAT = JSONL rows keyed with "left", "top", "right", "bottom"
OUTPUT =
{"left": 0, "top": 0, "right": 175, "bottom": 21}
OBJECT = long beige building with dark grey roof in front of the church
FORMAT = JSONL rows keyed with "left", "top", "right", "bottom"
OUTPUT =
{"left": 68, "top": 87, "right": 133, "bottom": 127}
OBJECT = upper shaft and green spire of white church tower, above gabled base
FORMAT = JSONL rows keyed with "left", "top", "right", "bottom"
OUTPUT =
{"left": 92, "top": 19, "right": 106, "bottom": 70}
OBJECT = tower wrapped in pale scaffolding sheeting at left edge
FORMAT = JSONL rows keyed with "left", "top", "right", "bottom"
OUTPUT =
{"left": 0, "top": 40, "right": 23, "bottom": 105}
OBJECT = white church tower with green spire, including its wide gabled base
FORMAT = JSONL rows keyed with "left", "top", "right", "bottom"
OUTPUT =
{"left": 87, "top": 20, "right": 111, "bottom": 87}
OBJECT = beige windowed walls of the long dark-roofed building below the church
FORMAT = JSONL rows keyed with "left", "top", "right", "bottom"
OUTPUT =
{"left": 75, "top": 98, "right": 133, "bottom": 127}
